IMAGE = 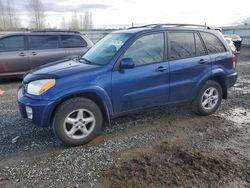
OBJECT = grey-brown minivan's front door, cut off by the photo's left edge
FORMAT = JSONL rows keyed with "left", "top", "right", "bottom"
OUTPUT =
{"left": 0, "top": 35, "right": 30, "bottom": 75}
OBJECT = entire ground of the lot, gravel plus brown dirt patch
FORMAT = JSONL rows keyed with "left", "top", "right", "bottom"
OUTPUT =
{"left": 0, "top": 49, "right": 250, "bottom": 187}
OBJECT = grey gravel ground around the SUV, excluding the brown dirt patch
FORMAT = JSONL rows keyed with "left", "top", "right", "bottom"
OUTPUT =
{"left": 0, "top": 49, "right": 250, "bottom": 187}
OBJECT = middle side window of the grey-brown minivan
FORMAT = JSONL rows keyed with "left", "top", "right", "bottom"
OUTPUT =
{"left": 29, "top": 35, "right": 59, "bottom": 50}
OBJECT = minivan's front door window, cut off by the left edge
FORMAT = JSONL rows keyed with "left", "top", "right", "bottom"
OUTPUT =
{"left": 0, "top": 36, "right": 24, "bottom": 52}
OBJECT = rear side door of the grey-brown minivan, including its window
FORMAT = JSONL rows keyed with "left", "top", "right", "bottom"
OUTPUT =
{"left": 28, "top": 35, "right": 67, "bottom": 68}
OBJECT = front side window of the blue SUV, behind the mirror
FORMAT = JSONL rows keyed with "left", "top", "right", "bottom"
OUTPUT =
{"left": 123, "top": 33, "right": 164, "bottom": 66}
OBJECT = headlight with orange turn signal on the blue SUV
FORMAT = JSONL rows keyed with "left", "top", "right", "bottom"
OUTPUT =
{"left": 27, "top": 79, "right": 56, "bottom": 95}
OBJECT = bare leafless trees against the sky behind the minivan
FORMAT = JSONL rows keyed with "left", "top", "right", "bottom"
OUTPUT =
{"left": 0, "top": 0, "right": 93, "bottom": 31}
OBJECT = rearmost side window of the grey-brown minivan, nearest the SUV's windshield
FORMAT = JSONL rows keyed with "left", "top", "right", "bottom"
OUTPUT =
{"left": 61, "top": 35, "right": 87, "bottom": 48}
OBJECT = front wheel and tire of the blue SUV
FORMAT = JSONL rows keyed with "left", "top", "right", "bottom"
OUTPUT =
{"left": 52, "top": 98, "right": 103, "bottom": 146}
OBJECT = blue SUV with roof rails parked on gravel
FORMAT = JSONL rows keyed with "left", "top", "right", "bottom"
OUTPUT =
{"left": 18, "top": 24, "right": 237, "bottom": 146}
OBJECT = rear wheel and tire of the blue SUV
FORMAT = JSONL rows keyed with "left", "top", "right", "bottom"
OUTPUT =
{"left": 192, "top": 80, "right": 222, "bottom": 116}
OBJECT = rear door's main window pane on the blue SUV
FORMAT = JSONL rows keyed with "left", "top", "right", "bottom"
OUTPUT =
{"left": 168, "top": 32, "right": 196, "bottom": 60}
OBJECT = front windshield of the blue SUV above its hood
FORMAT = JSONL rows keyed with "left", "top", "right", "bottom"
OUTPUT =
{"left": 80, "top": 33, "right": 130, "bottom": 65}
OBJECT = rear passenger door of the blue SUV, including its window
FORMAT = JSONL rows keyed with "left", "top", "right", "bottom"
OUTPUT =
{"left": 168, "top": 31, "right": 212, "bottom": 102}
